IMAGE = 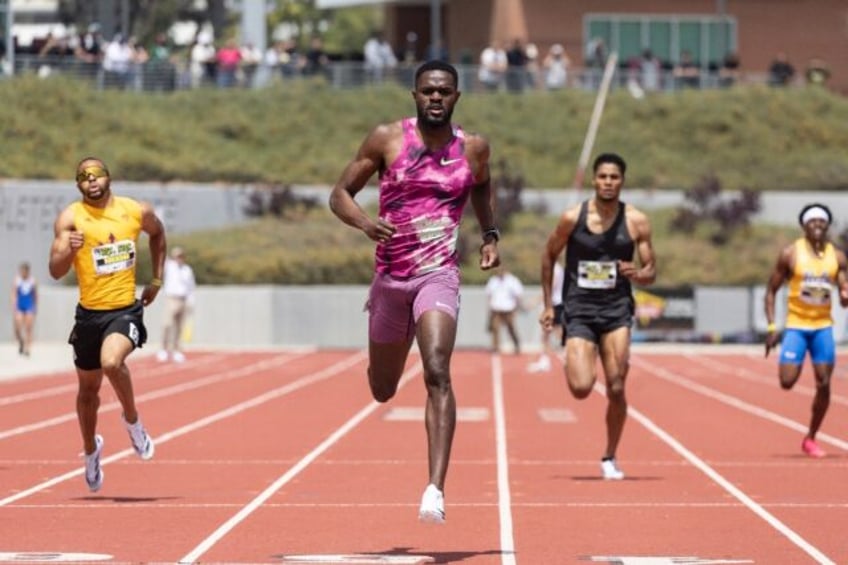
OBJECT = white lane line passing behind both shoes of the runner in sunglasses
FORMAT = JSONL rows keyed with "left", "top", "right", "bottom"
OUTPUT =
{"left": 0, "top": 351, "right": 365, "bottom": 507}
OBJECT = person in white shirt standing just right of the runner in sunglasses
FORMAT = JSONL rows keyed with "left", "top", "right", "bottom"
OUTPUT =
{"left": 157, "top": 247, "right": 195, "bottom": 363}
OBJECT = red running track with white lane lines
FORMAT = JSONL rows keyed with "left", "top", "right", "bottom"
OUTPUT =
{"left": 0, "top": 347, "right": 848, "bottom": 565}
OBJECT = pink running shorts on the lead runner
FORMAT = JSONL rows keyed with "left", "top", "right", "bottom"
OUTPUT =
{"left": 365, "top": 267, "right": 459, "bottom": 343}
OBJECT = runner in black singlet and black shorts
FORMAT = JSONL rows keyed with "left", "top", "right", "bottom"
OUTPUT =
{"left": 539, "top": 153, "right": 656, "bottom": 479}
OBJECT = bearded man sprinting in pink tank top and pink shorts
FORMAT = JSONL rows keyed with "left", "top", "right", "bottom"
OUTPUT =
{"left": 330, "top": 61, "right": 500, "bottom": 523}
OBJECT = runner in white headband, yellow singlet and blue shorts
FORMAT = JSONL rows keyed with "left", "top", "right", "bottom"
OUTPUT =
{"left": 765, "top": 204, "right": 848, "bottom": 457}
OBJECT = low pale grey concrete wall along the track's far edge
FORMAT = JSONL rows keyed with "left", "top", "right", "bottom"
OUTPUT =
{"left": 26, "top": 286, "right": 846, "bottom": 351}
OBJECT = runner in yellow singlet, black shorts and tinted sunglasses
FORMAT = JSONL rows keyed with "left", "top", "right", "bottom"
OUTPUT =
{"left": 50, "top": 157, "right": 166, "bottom": 492}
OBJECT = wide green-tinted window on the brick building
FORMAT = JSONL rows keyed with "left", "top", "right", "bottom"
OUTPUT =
{"left": 583, "top": 14, "right": 737, "bottom": 68}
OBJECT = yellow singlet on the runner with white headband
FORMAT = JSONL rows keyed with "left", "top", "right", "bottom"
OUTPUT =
{"left": 786, "top": 237, "right": 839, "bottom": 330}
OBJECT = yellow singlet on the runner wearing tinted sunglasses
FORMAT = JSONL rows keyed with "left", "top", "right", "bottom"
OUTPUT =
{"left": 71, "top": 196, "right": 141, "bottom": 310}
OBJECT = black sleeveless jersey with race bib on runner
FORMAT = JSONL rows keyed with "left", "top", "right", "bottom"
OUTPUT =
{"left": 562, "top": 201, "right": 635, "bottom": 310}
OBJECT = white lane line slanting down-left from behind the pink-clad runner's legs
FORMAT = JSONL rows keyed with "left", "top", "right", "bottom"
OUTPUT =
{"left": 177, "top": 363, "right": 421, "bottom": 563}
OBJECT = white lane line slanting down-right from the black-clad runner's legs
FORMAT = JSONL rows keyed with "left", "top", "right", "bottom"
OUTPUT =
{"left": 620, "top": 359, "right": 836, "bottom": 565}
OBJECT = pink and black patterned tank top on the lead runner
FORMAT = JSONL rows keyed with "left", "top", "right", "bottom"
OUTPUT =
{"left": 376, "top": 118, "right": 475, "bottom": 279}
